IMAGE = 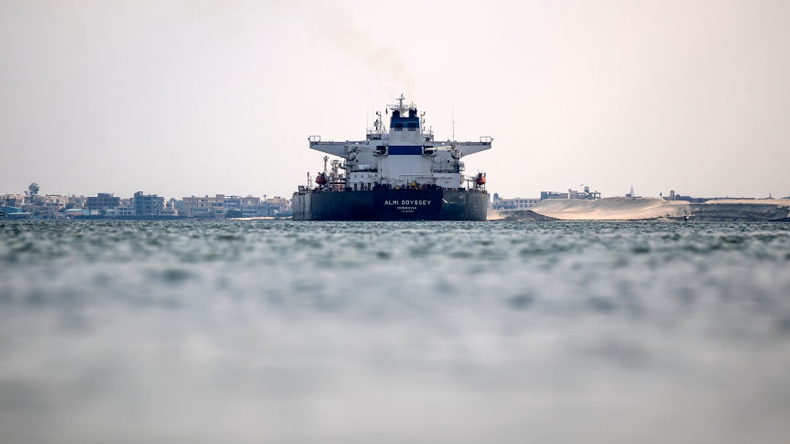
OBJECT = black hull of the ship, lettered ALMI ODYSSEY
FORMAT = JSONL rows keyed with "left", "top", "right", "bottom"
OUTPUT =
{"left": 292, "top": 189, "right": 488, "bottom": 221}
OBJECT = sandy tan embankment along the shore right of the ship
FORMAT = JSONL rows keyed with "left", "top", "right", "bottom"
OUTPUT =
{"left": 500, "top": 197, "right": 790, "bottom": 221}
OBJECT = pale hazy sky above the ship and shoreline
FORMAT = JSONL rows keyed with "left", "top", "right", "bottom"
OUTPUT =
{"left": 0, "top": 0, "right": 790, "bottom": 197}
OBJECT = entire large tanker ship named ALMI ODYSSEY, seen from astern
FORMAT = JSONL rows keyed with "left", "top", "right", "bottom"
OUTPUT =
{"left": 292, "top": 94, "right": 493, "bottom": 221}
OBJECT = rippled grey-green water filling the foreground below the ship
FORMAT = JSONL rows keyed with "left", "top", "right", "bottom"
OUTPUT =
{"left": 0, "top": 221, "right": 790, "bottom": 443}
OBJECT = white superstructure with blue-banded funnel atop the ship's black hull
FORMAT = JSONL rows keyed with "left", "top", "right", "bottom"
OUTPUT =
{"left": 309, "top": 94, "right": 493, "bottom": 190}
